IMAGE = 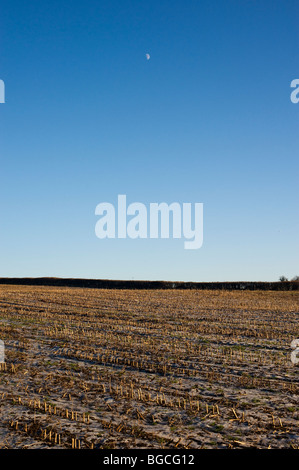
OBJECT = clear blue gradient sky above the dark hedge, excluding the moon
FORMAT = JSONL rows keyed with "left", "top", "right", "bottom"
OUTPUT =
{"left": 0, "top": 0, "right": 299, "bottom": 281}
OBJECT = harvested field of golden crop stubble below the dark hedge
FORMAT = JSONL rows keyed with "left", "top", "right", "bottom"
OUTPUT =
{"left": 0, "top": 285, "right": 299, "bottom": 449}
